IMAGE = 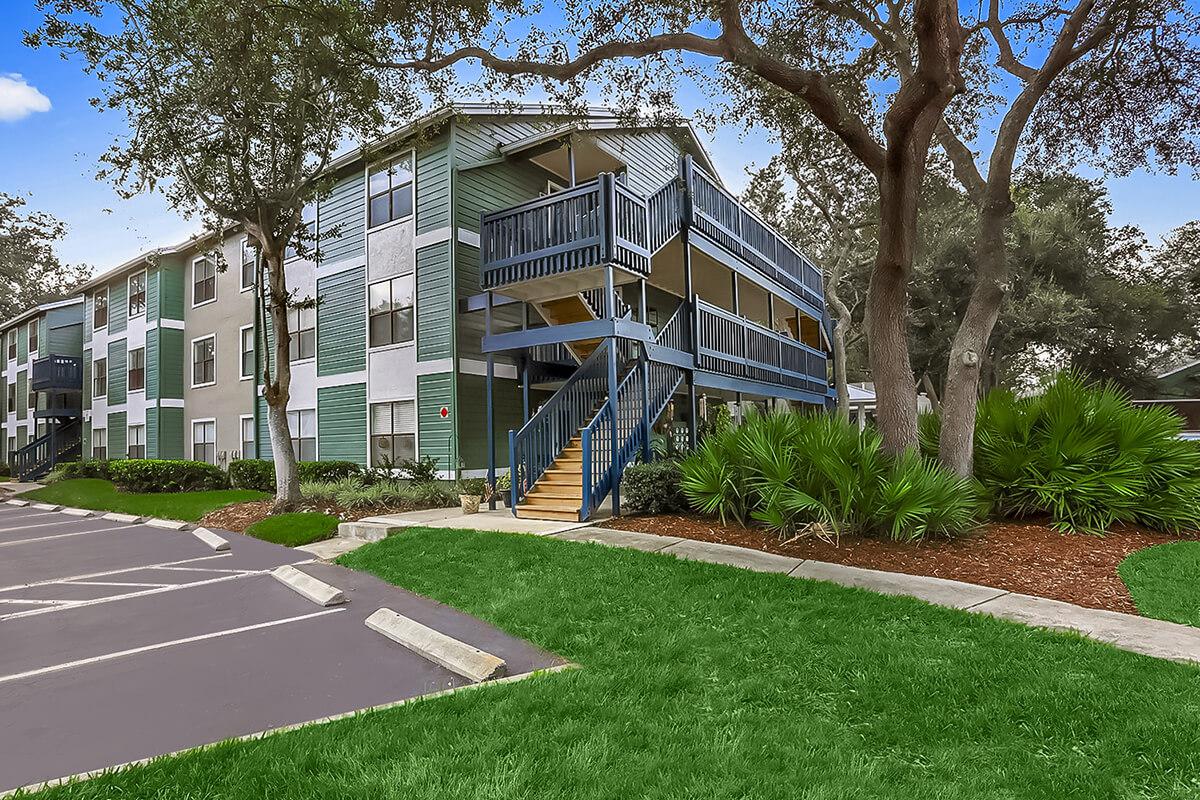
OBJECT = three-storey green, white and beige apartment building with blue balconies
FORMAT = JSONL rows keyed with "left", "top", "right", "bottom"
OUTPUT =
{"left": 0, "top": 106, "right": 828, "bottom": 518}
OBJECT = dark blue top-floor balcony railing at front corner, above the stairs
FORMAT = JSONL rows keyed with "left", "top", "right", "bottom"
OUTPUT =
{"left": 479, "top": 173, "right": 650, "bottom": 289}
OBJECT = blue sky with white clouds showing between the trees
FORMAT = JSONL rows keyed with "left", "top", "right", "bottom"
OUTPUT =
{"left": 0, "top": 0, "right": 1200, "bottom": 269}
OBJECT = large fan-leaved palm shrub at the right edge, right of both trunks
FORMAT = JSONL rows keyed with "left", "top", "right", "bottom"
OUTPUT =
{"left": 974, "top": 373, "right": 1200, "bottom": 533}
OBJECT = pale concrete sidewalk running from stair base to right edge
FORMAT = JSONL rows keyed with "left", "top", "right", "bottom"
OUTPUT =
{"left": 550, "top": 528, "right": 1200, "bottom": 662}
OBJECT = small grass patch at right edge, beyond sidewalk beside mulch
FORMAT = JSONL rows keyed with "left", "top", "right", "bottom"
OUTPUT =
{"left": 1117, "top": 541, "right": 1200, "bottom": 627}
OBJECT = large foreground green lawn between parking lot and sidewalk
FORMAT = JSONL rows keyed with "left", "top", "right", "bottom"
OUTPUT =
{"left": 25, "top": 529, "right": 1200, "bottom": 800}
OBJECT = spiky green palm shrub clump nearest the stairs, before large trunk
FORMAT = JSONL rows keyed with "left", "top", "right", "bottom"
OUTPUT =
{"left": 680, "top": 413, "right": 979, "bottom": 541}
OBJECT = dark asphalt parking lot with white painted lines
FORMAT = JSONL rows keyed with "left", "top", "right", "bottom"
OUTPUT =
{"left": 0, "top": 505, "right": 563, "bottom": 792}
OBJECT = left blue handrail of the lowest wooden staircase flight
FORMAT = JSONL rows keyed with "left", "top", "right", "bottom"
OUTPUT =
{"left": 509, "top": 339, "right": 611, "bottom": 513}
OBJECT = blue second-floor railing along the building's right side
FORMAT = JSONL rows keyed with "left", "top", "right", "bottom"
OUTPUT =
{"left": 695, "top": 299, "right": 829, "bottom": 395}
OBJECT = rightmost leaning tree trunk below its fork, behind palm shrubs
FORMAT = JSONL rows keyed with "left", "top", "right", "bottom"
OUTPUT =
{"left": 938, "top": 203, "right": 1014, "bottom": 476}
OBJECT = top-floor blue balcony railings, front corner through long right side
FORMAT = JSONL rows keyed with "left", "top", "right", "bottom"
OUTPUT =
{"left": 480, "top": 157, "right": 824, "bottom": 308}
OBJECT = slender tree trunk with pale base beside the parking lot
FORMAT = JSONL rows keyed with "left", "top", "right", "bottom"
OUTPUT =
{"left": 263, "top": 248, "right": 300, "bottom": 513}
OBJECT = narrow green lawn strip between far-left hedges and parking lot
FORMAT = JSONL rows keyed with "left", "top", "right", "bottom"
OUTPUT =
{"left": 20, "top": 477, "right": 269, "bottom": 522}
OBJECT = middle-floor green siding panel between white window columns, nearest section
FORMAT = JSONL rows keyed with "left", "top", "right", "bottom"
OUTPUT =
{"left": 317, "top": 266, "right": 367, "bottom": 375}
